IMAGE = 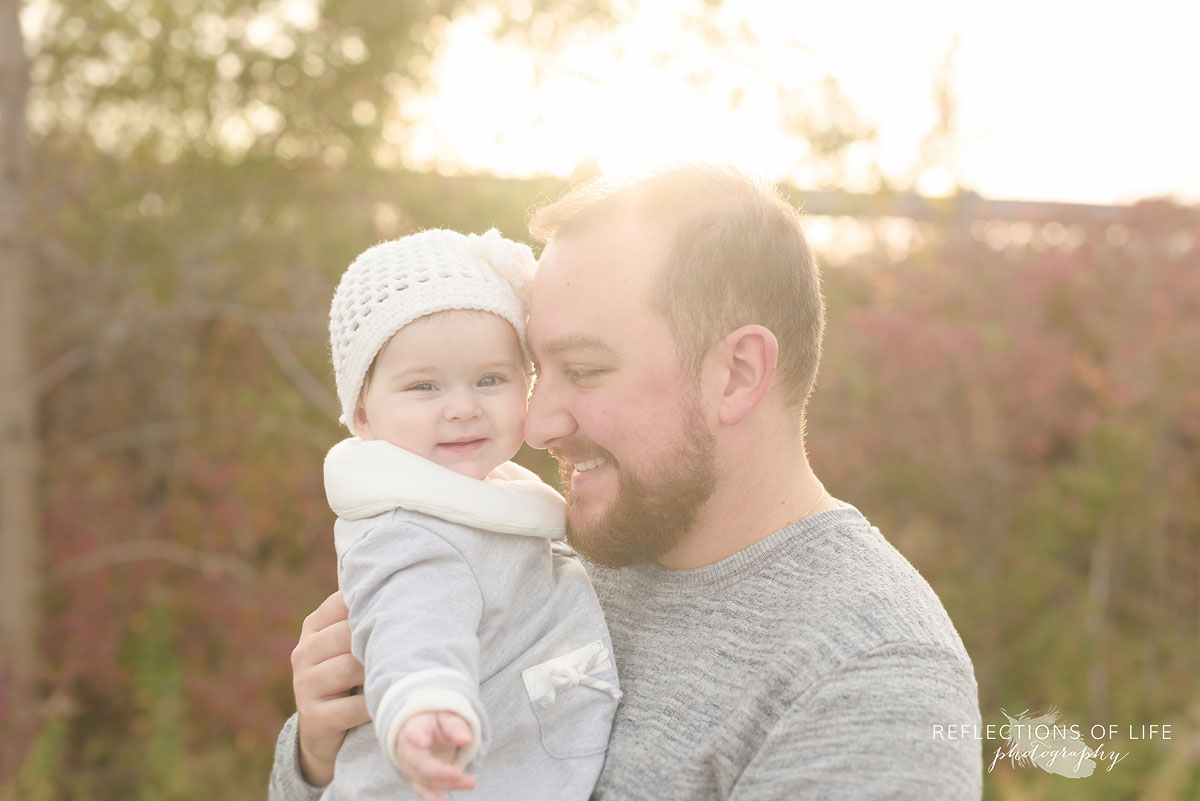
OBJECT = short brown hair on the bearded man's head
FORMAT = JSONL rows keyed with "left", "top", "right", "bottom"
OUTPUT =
{"left": 529, "top": 164, "right": 824, "bottom": 411}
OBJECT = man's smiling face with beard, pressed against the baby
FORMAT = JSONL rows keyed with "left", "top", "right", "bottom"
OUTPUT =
{"left": 526, "top": 223, "right": 714, "bottom": 566}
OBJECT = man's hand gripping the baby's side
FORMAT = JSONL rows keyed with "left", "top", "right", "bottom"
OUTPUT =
{"left": 292, "top": 591, "right": 371, "bottom": 787}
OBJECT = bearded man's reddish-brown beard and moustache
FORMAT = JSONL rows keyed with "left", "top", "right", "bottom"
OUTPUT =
{"left": 558, "top": 410, "right": 716, "bottom": 567}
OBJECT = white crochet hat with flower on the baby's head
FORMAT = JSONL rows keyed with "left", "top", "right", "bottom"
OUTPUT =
{"left": 329, "top": 228, "right": 534, "bottom": 434}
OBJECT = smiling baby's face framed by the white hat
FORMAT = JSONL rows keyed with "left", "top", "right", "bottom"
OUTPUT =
{"left": 354, "top": 309, "right": 529, "bottom": 478}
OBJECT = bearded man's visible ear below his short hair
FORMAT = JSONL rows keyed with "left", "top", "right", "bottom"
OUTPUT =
{"left": 704, "top": 324, "right": 779, "bottom": 426}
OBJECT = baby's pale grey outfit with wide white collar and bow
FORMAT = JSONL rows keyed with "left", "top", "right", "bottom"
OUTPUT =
{"left": 322, "top": 438, "right": 619, "bottom": 801}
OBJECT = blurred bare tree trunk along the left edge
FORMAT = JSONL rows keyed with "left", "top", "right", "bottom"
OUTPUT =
{"left": 0, "top": 0, "right": 42, "bottom": 777}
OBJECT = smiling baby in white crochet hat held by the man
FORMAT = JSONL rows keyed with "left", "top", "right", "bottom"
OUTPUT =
{"left": 322, "top": 230, "right": 620, "bottom": 801}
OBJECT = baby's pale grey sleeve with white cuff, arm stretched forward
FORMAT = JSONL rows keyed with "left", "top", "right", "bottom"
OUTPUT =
{"left": 338, "top": 516, "right": 487, "bottom": 767}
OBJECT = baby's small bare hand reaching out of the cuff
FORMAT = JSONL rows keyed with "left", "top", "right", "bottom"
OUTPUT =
{"left": 396, "top": 712, "right": 475, "bottom": 801}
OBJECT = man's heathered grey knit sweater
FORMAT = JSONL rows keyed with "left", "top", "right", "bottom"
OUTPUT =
{"left": 271, "top": 507, "right": 983, "bottom": 801}
